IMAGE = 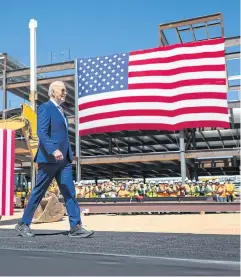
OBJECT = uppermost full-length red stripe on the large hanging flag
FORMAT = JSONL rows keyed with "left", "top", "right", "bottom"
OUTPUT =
{"left": 79, "top": 92, "right": 227, "bottom": 111}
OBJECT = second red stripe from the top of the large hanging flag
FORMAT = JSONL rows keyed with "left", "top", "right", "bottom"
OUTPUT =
{"left": 129, "top": 50, "right": 224, "bottom": 66}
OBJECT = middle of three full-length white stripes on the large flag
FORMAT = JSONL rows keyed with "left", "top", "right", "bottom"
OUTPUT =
{"left": 79, "top": 99, "right": 228, "bottom": 117}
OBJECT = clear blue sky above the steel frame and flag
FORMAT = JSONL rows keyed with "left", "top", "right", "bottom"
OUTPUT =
{"left": 0, "top": 0, "right": 240, "bottom": 109}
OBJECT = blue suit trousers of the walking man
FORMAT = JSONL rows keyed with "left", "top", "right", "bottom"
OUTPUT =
{"left": 22, "top": 159, "right": 81, "bottom": 227}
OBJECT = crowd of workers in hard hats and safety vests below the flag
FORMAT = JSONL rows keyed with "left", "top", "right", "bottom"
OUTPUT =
{"left": 75, "top": 179, "right": 235, "bottom": 202}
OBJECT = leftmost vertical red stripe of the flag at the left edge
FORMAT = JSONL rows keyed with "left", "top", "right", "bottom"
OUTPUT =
{"left": 2, "top": 130, "right": 7, "bottom": 215}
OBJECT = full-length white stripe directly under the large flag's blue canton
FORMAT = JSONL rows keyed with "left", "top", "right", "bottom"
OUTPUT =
{"left": 78, "top": 85, "right": 227, "bottom": 105}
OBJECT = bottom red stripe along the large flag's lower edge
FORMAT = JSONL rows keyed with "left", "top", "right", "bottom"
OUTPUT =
{"left": 79, "top": 121, "right": 230, "bottom": 136}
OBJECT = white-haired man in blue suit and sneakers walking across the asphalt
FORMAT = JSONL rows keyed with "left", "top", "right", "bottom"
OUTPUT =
{"left": 15, "top": 81, "right": 94, "bottom": 237}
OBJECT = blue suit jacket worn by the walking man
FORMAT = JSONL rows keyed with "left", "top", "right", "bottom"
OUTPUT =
{"left": 34, "top": 100, "right": 73, "bottom": 163}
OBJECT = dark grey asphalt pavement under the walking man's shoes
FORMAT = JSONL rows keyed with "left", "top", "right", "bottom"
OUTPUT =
{"left": 0, "top": 229, "right": 240, "bottom": 276}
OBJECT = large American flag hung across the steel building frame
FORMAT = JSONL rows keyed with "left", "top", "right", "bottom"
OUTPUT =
{"left": 77, "top": 38, "right": 229, "bottom": 136}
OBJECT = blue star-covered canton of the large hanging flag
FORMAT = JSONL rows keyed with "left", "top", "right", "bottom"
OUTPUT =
{"left": 78, "top": 53, "right": 129, "bottom": 97}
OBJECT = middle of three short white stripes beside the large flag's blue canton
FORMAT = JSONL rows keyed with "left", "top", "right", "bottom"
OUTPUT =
{"left": 128, "top": 57, "right": 225, "bottom": 72}
